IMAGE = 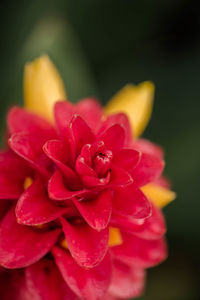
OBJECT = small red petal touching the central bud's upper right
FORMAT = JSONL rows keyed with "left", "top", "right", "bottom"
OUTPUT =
{"left": 98, "top": 124, "right": 125, "bottom": 152}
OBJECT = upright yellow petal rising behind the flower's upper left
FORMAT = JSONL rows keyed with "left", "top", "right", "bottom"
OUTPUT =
{"left": 24, "top": 55, "right": 66, "bottom": 121}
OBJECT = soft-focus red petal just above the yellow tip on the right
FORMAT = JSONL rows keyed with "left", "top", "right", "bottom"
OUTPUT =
{"left": 130, "top": 153, "right": 164, "bottom": 186}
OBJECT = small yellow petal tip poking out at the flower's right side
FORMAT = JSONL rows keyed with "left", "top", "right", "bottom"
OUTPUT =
{"left": 142, "top": 183, "right": 176, "bottom": 208}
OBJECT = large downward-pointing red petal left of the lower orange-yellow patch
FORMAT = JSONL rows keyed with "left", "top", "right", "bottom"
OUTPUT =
{"left": 61, "top": 218, "right": 109, "bottom": 268}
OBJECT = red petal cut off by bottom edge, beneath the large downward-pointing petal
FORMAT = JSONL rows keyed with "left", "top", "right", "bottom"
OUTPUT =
{"left": 53, "top": 247, "right": 111, "bottom": 300}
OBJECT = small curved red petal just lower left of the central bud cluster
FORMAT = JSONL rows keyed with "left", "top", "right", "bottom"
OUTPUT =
{"left": 48, "top": 171, "right": 87, "bottom": 200}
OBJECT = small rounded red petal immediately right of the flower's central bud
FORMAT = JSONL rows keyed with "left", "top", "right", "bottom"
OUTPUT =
{"left": 113, "top": 148, "right": 141, "bottom": 171}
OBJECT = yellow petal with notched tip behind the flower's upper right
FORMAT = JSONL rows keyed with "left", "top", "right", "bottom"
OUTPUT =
{"left": 105, "top": 81, "right": 154, "bottom": 137}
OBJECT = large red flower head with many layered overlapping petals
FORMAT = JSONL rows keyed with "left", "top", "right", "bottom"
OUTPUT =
{"left": 0, "top": 58, "right": 174, "bottom": 300}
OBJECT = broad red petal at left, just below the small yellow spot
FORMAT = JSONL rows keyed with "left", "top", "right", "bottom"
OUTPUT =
{"left": 16, "top": 179, "right": 68, "bottom": 225}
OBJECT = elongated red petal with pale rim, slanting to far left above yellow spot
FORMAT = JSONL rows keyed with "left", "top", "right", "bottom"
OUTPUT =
{"left": 9, "top": 133, "right": 49, "bottom": 176}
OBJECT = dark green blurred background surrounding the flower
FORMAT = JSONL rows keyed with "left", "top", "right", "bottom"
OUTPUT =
{"left": 0, "top": 0, "right": 200, "bottom": 300}
